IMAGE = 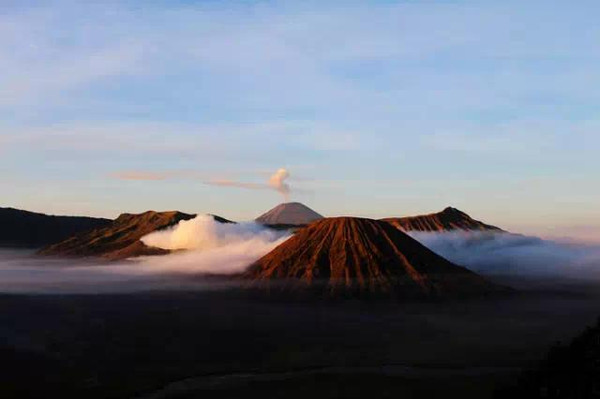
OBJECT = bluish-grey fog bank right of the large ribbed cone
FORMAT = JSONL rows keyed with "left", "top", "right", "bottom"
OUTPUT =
{"left": 410, "top": 232, "right": 600, "bottom": 281}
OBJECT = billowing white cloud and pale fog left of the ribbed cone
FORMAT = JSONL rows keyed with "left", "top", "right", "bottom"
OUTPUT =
{"left": 0, "top": 215, "right": 289, "bottom": 293}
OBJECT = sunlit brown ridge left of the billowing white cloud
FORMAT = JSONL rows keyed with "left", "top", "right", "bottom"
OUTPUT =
{"left": 39, "top": 211, "right": 233, "bottom": 260}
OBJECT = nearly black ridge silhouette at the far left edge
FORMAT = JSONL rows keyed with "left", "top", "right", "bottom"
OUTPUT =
{"left": 0, "top": 208, "right": 111, "bottom": 248}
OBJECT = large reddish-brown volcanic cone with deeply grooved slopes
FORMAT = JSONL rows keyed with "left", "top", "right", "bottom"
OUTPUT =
{"left": 243, "top": 217, "right": 498, "bottom": 297}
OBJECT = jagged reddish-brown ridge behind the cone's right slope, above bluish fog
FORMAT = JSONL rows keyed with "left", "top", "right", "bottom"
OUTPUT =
{"left": 382, "top": 207, "right": 504, "bottom": 232}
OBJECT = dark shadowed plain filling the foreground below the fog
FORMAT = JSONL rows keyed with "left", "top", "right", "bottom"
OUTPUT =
{"left": 0, "top": 281, "right": 600, "bottom": 398}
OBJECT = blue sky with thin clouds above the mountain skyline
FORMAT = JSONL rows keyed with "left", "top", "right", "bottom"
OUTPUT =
{"left": 0, "top": 0, "right": 600, "bottom": 239}
